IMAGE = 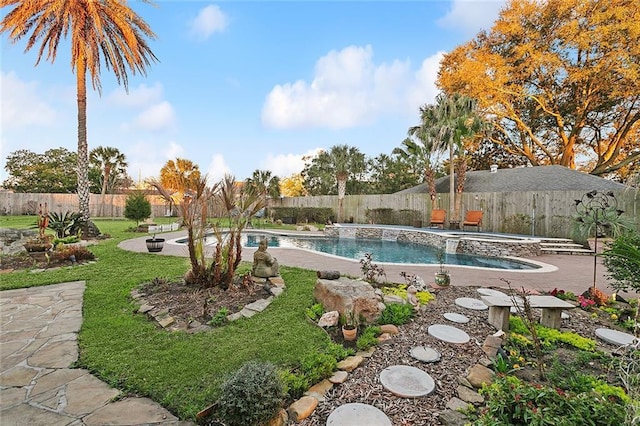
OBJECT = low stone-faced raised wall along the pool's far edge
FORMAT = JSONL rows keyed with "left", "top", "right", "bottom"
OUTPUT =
{"left": 324, "top": 225, "right": 541, "bottom": 257}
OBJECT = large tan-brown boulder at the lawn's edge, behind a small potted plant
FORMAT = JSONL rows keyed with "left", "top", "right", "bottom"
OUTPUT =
{"left": 313, "top": 277, "right": 384, "bottom": 323}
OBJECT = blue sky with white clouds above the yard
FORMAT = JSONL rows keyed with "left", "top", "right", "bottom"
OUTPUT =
{"left": 0, "top": 0, "right": 504, "bottom": 186}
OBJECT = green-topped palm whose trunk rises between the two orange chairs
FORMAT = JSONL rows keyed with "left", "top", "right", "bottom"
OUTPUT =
{"left": 433, "top": 93, "right": 482, "bottom": 220}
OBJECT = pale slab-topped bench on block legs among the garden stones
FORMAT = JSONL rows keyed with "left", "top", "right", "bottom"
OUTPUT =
{"left": 480, "top": 296, "right": 576, "bottom": 331}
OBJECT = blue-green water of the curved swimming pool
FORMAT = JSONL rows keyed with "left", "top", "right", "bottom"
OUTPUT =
{"left": 175, "top": 232, "right": 540, "bottom": 270}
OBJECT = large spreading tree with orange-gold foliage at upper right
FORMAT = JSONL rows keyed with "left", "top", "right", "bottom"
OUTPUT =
{"left": 438, "top": 0, "right": 640, "bottom": 175}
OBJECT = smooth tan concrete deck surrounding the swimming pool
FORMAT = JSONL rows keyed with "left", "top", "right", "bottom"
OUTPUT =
{"left": 119, "top": 230, "right": 613, "bottom": 300}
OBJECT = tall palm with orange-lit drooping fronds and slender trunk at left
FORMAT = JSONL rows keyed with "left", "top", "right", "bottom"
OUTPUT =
{"left": 0, "top": 0, "right": 157, "bottom": 233}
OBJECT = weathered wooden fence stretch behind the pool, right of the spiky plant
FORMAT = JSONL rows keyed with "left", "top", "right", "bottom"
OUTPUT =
{"left": 284, "top": 189, "right": 640, "bottom": 238}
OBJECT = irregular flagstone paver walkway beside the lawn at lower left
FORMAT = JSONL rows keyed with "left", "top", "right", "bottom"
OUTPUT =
{"left": 0, "top": 281, "right": 191, "bottom": 426}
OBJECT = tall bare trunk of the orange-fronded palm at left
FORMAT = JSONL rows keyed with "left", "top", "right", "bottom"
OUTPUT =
{"left": 76, "top": 54, "right": 90, "bottom": 223}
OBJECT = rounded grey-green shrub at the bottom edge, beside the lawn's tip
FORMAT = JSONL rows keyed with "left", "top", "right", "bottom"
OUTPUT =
{"left": 217, "top": 361, "right": 285, "bottom": 426}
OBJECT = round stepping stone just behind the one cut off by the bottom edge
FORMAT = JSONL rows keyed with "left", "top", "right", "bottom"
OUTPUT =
{"left": 380, "top": 365, "right": 436, "bottom": 398}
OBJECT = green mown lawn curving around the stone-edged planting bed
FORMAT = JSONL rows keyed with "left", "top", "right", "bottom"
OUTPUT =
{"left": 0, "top": 216, "right": 330, "bottom": 420}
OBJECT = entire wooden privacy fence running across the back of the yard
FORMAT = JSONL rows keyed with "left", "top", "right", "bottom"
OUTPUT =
{"left": 0, "top": 189, "right": 640, "bottom": 237}
